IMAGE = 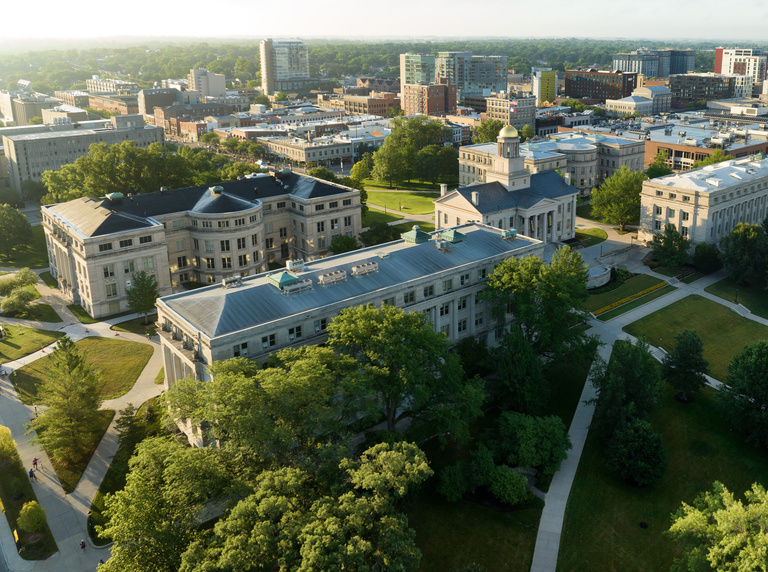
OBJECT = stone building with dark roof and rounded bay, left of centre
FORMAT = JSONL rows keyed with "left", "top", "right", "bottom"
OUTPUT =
{"left": 42, "top": 171, "right": 361, "bottom": 318}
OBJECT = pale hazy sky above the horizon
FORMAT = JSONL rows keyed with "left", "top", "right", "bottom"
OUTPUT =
{"left": 6, "top": 0, "right": 768, "bottom": 41}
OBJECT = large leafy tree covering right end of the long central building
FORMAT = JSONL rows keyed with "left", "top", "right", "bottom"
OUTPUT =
{"left": 481, "top": 246, "right": 588, "bottom": 356}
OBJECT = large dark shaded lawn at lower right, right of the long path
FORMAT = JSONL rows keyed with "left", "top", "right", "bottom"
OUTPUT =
{"left": 557, "top": 387, "right": 768, "bottom": 572}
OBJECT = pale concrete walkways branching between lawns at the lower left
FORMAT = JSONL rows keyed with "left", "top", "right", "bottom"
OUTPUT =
{"left": 0, "top": 269, "right": 163, "bottom": 572}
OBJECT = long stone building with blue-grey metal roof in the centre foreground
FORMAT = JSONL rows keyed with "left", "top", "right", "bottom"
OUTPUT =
{"left": 157, "top": 223, "right": 544, "bottom": 398}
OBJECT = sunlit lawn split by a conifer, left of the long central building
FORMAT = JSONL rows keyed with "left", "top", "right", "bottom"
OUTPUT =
{"left": 12, "top": 338, "right": 153, "bottom": 405}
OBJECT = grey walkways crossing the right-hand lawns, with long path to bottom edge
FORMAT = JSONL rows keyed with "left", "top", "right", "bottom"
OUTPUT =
{"left": 531, "top": 264, "right": 768, "bottom": 572}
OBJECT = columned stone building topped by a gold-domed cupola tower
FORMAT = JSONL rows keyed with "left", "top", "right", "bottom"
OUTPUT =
{"left": 435, "top": 125, "right": 578, "bottom": 243}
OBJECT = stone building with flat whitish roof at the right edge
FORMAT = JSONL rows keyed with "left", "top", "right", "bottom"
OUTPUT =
{"left": 638, "top": 155, "right": 768, "bottom": 246}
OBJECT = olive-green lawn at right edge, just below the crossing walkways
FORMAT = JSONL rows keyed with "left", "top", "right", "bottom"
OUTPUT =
{"left": 624, "top": 294, "right": 768, "bottom": 382}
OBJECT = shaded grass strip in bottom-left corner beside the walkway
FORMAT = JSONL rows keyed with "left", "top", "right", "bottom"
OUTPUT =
{"left": 0, "top": 432, "right": 58, "bottom": 560}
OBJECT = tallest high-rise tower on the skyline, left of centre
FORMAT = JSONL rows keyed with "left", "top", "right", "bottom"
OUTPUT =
{"left": 260, "top": 38, "right": 311, "bottom": 95}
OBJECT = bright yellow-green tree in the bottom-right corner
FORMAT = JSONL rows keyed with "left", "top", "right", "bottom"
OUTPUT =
{"left": 667, "top": 481, "right": 768, "bottom": 572}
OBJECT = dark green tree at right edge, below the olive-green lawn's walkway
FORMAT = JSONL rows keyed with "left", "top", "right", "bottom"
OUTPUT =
{"left": 718, "top": 340, "right": 768, "bottom": 446}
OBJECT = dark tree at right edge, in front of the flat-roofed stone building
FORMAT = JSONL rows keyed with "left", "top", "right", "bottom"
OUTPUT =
{"left": 720, "top": 222, "right": 768, "bottom": 286}
